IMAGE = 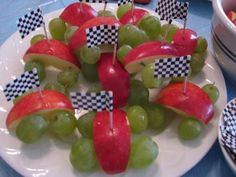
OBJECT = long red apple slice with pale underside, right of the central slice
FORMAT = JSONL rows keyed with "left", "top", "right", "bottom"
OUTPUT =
{"left": 124, "top": 41, "right": 179, "bottom": 73}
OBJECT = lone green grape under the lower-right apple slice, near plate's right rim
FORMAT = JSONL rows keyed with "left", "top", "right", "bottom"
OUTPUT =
{"left": 178, "top": 117, "right": 202, "bottom": 140}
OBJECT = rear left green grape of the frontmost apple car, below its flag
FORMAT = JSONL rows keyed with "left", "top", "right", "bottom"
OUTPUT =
{"left": 77, "top": 111, "right": 96, "bottom": 138}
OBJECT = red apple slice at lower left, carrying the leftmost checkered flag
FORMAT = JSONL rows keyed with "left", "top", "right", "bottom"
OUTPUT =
{"left": 6, "top": 90, "right": 74, "bottom": 129}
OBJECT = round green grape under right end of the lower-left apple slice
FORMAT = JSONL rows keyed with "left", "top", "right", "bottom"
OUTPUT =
{"left": 49, "top": 110, "right": 76, "bottom": 136}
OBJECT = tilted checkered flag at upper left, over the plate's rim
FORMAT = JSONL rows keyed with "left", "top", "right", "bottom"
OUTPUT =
{"left": 17, "top": 8, "right": 44, "bottom": 39}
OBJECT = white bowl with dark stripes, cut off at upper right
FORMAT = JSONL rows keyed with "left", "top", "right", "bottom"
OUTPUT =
{"left": 211, "top": 0, "right": 236, "bottom": 84}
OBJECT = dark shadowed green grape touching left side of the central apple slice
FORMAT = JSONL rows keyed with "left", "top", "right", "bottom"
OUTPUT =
{"left": 81, "top": 63, "right": 98, "bottom": 82}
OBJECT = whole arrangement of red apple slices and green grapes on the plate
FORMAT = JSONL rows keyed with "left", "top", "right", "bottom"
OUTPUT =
{"left": 3, "top": 2, "right": 220, "bottom": 174}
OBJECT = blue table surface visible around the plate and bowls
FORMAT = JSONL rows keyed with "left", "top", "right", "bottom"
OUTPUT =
{"left": 0, "top": 0, "right": 236, "bottom": 177}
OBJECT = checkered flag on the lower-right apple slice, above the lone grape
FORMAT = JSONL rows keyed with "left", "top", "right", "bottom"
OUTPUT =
{"left": 154, "top": 55, "right": 191, "bottom": 78}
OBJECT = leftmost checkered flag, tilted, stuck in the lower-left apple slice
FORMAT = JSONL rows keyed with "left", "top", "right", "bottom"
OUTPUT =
{"left": 3, "top": 68, "right": 40, "bottom": 101}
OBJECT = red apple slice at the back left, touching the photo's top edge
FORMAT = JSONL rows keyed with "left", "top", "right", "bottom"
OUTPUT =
{"left": 60, "top": 2, "right": 97, "bottom": 27}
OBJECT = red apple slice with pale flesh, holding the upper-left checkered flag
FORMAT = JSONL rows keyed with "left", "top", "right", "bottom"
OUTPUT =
{"left": 24, "top": 39, "right": 80, "bottom": 71}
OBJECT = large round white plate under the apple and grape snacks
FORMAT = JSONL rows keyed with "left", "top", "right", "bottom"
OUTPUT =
{"left": 0, "top": 4, "right": 227, "bottom": 177}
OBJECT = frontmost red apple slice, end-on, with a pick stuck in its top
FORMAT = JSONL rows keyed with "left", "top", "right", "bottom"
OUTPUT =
{"left": 93, "top": 109, "right": 130, "bottom": 174}
